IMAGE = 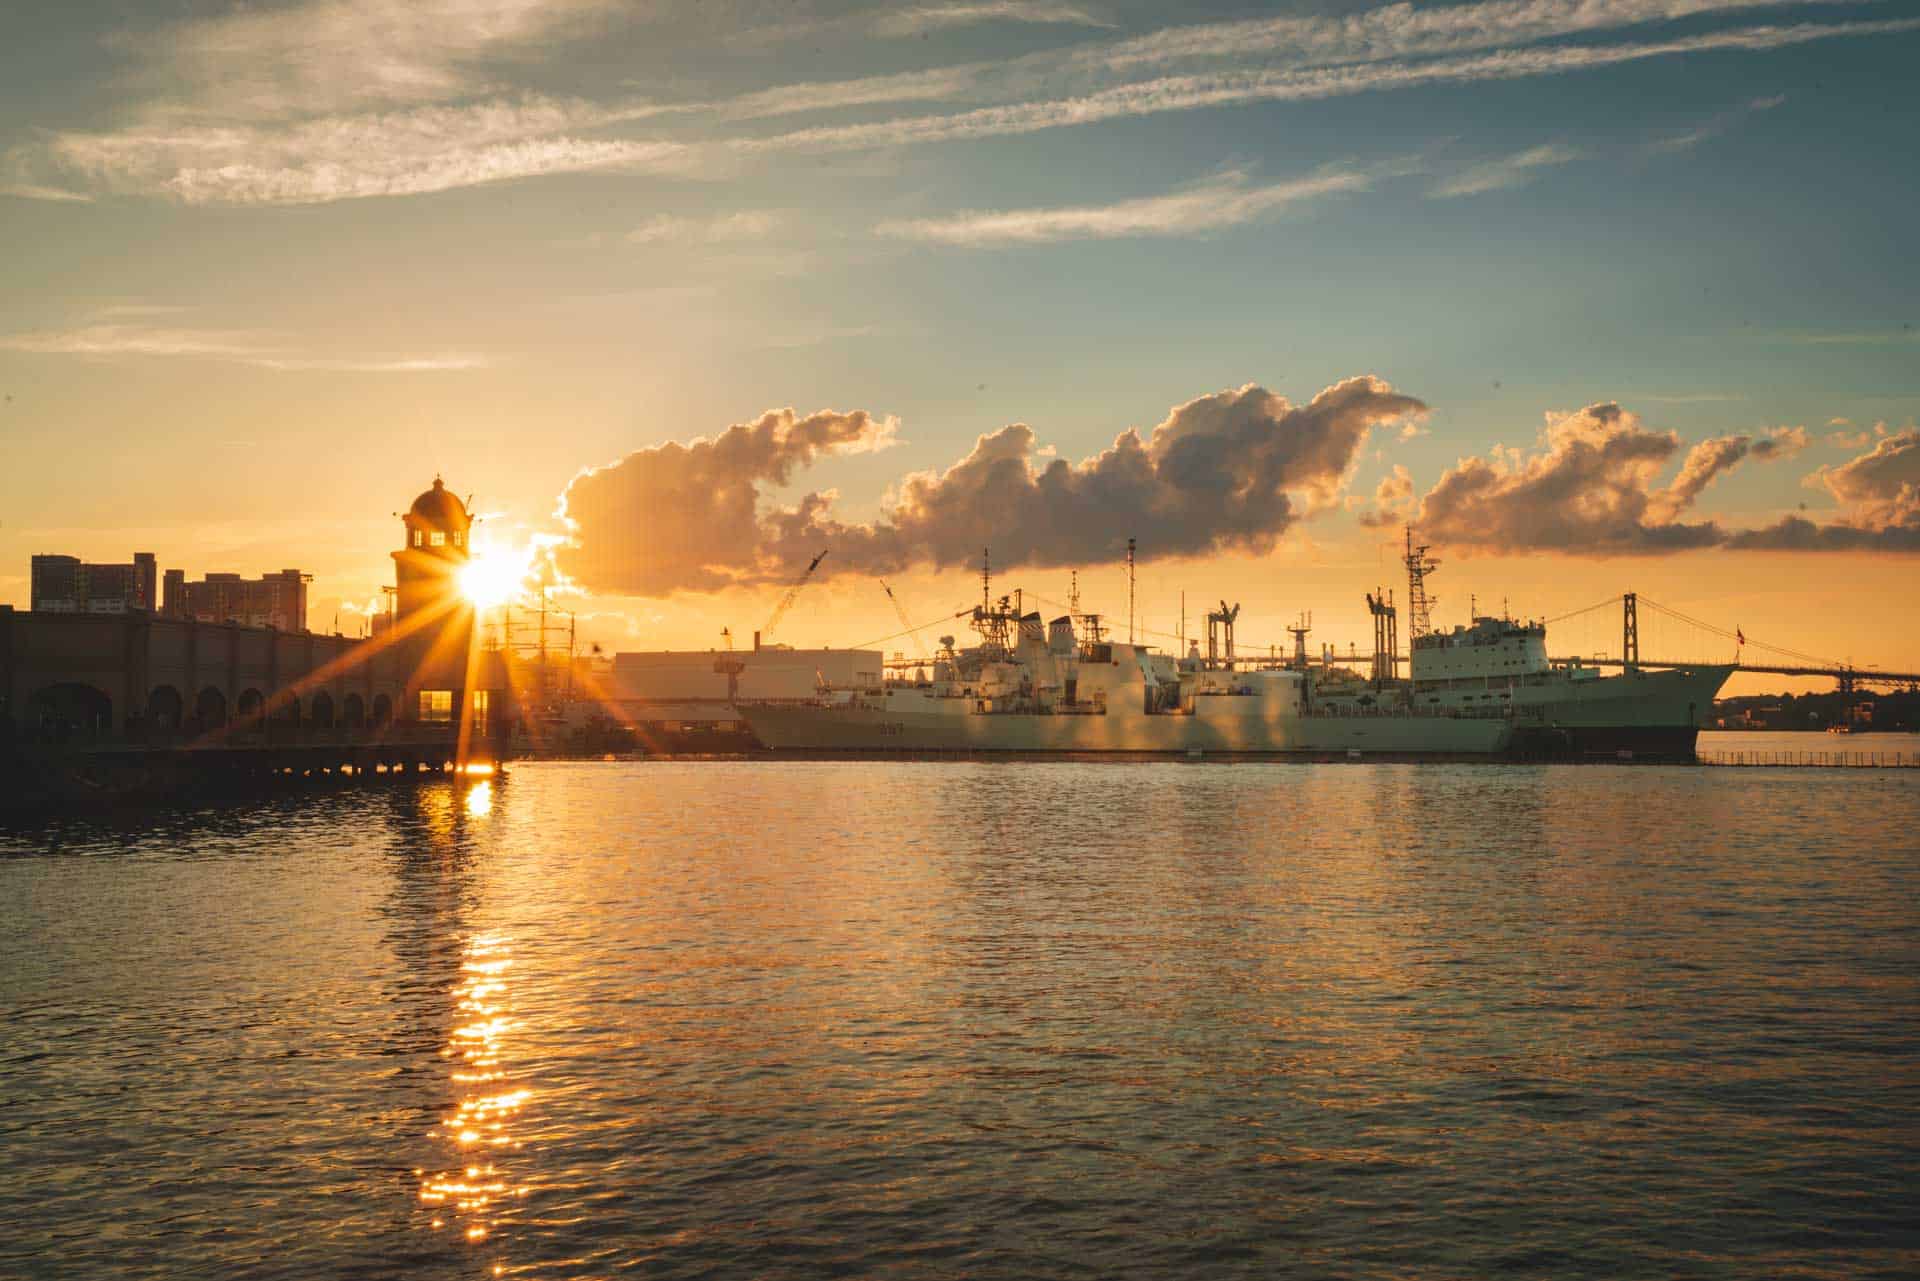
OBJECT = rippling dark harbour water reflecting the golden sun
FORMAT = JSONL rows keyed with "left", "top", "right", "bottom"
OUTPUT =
{"left": 0, "top": 762, "right": 1920, "bottom": 1277}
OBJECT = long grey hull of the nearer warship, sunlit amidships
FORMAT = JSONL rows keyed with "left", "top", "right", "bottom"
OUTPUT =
{"left": 739, "top": 705, "right": 1513, "bottom": 761}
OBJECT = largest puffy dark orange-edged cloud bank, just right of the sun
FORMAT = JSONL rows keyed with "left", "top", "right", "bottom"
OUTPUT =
{"left": 561, "top": 376, "right": 1427, "bottom": 595}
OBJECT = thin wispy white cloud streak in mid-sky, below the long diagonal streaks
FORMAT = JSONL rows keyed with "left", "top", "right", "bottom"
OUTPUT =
{"left": 874, "top": 171, "right": 1371, "bottom": 250}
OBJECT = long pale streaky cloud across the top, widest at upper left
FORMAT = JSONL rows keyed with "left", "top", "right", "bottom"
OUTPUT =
{"left": 6, "top": 0, "right": 1920, "bottom": 204}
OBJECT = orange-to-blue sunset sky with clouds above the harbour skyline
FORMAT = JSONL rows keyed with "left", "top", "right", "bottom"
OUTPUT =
{"left": 0, "top": 0, "right": 1920, "bottom": 691}
